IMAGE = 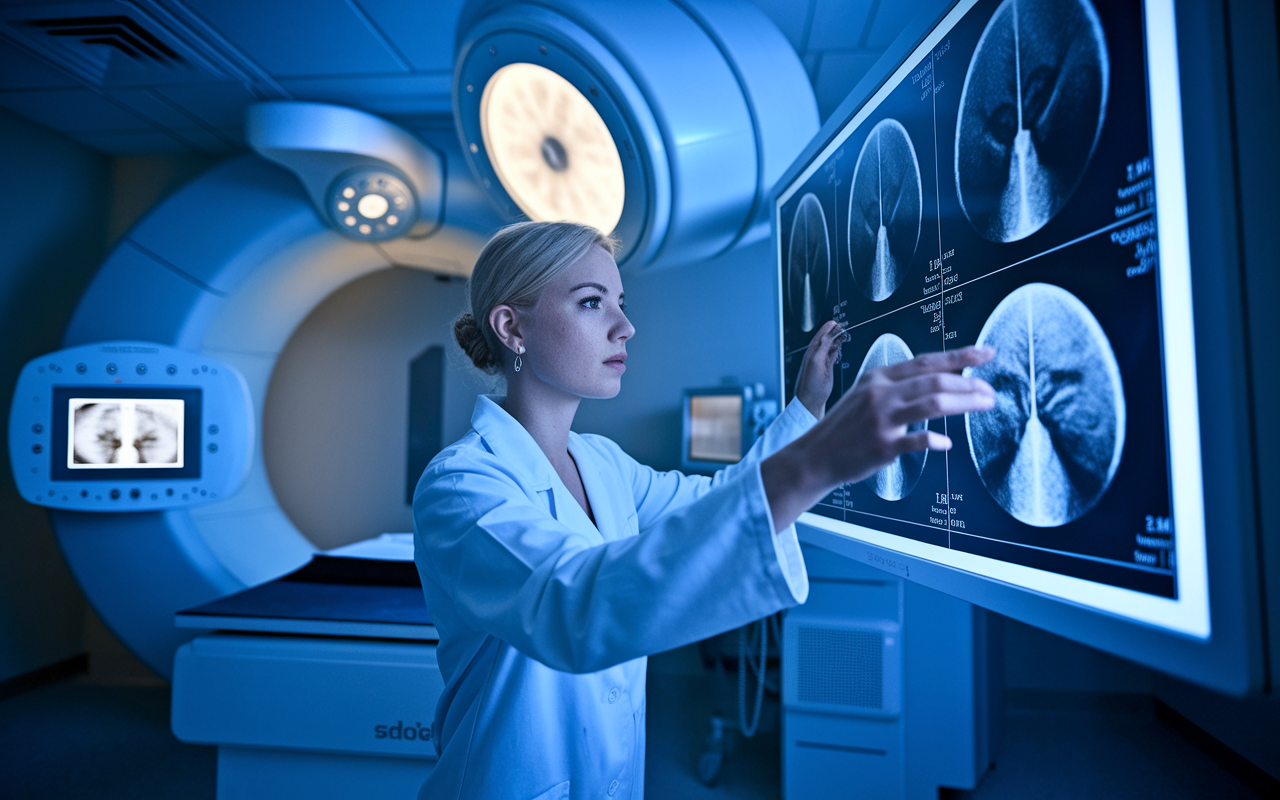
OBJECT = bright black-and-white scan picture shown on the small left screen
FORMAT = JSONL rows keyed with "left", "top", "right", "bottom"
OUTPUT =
{"left": 67, "top": 398, "right": 183, "bottom": 468}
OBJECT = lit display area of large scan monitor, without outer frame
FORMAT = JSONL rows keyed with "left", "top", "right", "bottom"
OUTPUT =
{"left": 774, "top": 0, "right": 1210, "bottom": 637}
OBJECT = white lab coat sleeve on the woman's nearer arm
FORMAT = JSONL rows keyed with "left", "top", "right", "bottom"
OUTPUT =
{"left": 413, "top": 457, "right": 803, "bottom": 672}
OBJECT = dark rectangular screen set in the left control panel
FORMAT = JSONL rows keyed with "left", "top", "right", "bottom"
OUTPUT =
{"left": 50, "top": 387, "right": 201, "bottom": 480}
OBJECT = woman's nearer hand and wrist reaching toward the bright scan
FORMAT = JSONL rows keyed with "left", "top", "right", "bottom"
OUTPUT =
{"left": 760, "top": 347, "right": 996, "bottom": 531}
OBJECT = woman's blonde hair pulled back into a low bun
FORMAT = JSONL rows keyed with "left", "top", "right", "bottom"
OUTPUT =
{"left": 453, "top": 223, "right": 618, "bottom": 374}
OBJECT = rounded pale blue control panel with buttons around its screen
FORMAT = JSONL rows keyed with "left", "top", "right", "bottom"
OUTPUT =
{"left": 9, "top": 342, "right": 255, "bottom": 512}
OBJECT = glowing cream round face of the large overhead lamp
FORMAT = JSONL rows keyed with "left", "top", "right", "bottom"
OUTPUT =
{"left": 480, "top": 63, "right": 626, "bottom": 233}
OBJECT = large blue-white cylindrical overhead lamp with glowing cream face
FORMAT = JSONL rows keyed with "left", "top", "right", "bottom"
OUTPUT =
{"left": 453, "top": 0, "right": 818, "bottom": 268}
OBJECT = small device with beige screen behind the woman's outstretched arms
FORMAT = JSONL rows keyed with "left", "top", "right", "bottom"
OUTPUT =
{"left": 680, "top": 384, "right": 778, "bottom": 472}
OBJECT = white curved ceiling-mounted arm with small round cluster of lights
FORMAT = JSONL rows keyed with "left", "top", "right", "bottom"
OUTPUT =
{"left": 244, "top": 101, "right": 444, "bottom": 242}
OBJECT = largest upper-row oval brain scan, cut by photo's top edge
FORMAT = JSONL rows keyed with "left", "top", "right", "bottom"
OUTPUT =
{"left": 955, "top": 0, "right": 1110, "bottom": 242}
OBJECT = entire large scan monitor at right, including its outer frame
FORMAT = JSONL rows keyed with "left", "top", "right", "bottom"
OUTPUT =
{"left": 773, "top": 0, "right": 1280, "bottom": 694}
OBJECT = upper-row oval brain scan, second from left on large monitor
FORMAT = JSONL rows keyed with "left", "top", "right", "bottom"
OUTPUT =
{"left": 849, "top": 119, "right": 924, "bottom": 302}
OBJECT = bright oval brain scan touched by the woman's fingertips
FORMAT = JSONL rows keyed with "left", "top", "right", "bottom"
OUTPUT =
{"left": 965, "top": 283, "right": 1125, "bottom": 527}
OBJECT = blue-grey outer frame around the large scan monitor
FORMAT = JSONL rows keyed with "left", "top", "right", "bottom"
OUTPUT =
{"left": 768, "top": 0, "right": 1277, "bottom": 695}
